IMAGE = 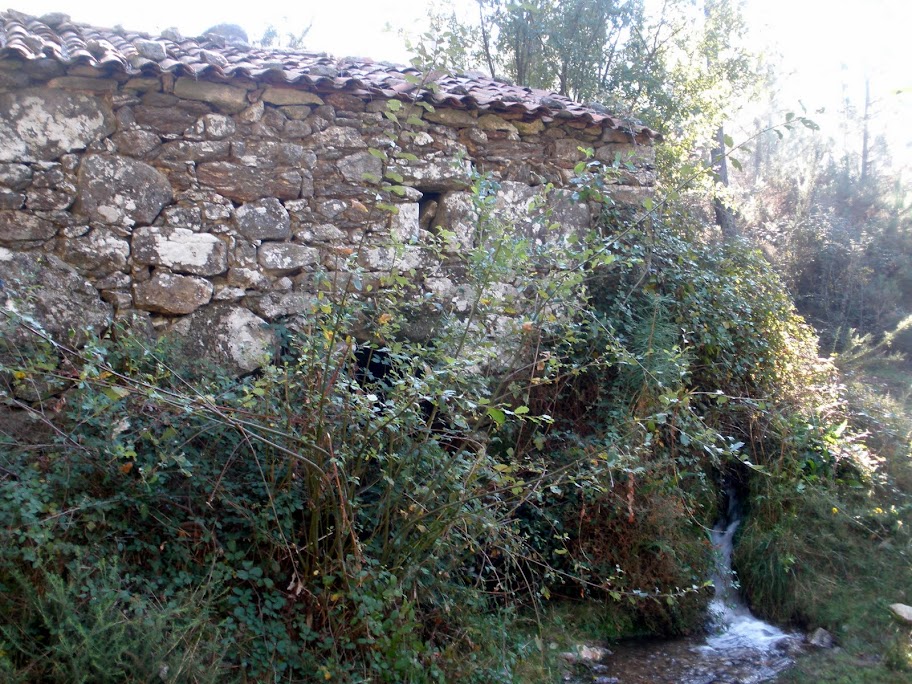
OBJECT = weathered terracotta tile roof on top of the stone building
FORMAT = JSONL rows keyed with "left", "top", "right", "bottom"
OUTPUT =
{"left": 0, "top": 10, "right": 659, "bottom": 138}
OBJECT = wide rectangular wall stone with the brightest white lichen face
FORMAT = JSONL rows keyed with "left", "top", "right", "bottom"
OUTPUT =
{"left": 133, "top": 226, "right": 228, "bottom": 276}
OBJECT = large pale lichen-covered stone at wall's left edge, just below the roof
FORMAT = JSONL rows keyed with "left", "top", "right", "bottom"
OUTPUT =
{"left": 0, "top": 88, "right": 115, "bottom": 162}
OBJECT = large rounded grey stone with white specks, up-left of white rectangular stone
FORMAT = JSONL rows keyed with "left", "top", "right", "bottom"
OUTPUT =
{"left": 77, "top": 154, "right": 172, "bottom": 227}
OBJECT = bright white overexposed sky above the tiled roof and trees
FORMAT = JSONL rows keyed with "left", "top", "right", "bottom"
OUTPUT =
{"left": 7, "top": 0, "right": 912, "bottom": 164}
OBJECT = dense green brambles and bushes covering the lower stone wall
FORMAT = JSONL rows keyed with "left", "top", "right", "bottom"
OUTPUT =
{"left": 0, "top": 163, "right": 868, "bottom": 682}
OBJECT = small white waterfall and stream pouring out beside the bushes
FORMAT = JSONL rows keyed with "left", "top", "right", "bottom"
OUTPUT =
{"left": 569, "top": 489, "right": 803, "bottom": 684}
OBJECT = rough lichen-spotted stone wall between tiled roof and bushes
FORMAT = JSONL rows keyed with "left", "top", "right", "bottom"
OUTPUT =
{"left": 0, "top": 54, "right": 654, "bottom": 371}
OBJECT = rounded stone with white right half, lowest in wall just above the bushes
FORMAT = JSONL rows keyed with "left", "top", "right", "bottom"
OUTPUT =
{"left": 170, "top": 303, "right": 275, "bottom": 375}
